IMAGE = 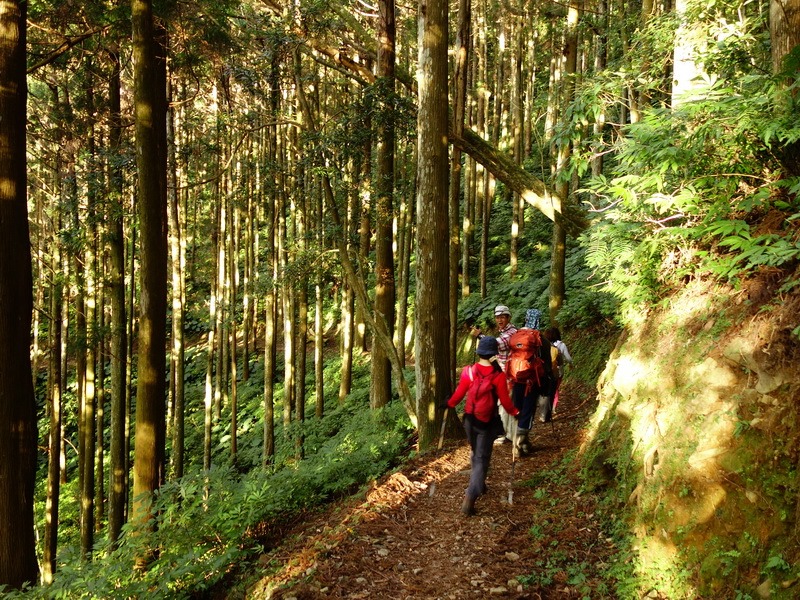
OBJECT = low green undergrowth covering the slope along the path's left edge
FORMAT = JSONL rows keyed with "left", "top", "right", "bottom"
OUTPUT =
{"left": 29, "top": 396, "right": 412, "bottom": 598}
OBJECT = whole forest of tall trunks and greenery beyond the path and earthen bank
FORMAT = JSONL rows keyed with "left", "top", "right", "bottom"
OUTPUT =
{"left": 0, "top": 0, "right": 800, "bottom": 597}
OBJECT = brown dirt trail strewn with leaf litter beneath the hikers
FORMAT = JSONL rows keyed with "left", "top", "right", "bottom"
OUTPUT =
{"left": 247, "top": 381, "right": 614, "bottom": 600}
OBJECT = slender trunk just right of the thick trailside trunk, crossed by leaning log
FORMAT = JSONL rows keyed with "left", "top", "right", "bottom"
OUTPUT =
{"left": 448, "top": 0, "right": 472, "bottom": 373}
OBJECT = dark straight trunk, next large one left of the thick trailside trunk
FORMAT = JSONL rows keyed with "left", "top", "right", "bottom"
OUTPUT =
{"left": 370, "top": 0, "right": 395, "bottom": 408}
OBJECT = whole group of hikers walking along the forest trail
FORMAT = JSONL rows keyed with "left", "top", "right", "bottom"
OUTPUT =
{"left": 442, "top": 304, "right": 573, "bottom": 516}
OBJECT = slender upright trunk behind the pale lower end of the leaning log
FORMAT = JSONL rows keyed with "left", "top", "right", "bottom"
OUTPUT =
{"left": 549, "top": 0, "right": 583, "bottom": 327}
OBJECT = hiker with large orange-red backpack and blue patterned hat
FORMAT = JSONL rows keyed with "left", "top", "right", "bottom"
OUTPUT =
{"left": 506, "top": 308, "right": 554, "bottom": 455}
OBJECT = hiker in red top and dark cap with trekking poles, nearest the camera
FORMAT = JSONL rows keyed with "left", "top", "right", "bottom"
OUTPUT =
{"left": 445, "top": 336, "right": 519, "bottom": 516}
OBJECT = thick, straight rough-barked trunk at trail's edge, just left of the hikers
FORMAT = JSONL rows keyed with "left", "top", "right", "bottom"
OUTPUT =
{"left": 414, "top": 0, "right": 452, "bottom": 450}
